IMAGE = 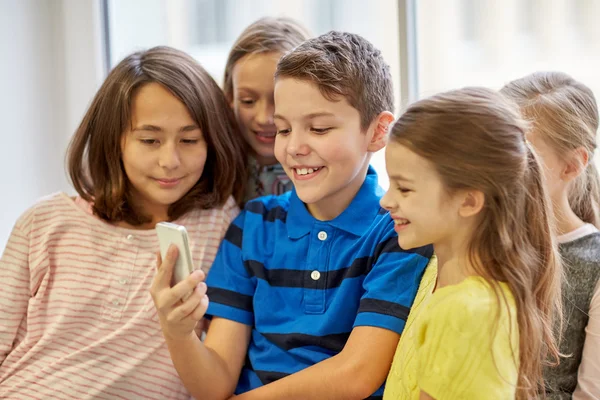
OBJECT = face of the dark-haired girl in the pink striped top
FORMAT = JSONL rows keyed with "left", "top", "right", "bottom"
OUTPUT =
{"left": 121, "top": 83, "right": 207, "bottom": 218}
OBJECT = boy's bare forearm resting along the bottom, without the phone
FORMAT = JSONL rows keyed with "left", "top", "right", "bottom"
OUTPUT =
{"left": 236, "top": 326, "right": 400, "bottom": 400}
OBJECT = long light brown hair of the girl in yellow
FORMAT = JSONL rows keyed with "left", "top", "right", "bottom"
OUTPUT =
{"left": 391, "top": 88, "right": 561, "bottom": 398}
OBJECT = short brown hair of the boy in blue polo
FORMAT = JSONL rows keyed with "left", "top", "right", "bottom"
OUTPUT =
{"left": 275, "top": 31, "right": 394, "bottom": 129}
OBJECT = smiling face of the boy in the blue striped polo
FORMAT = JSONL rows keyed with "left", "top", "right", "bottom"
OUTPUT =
{"left": 275, "top": 78, "right": 374, "bottom": 220}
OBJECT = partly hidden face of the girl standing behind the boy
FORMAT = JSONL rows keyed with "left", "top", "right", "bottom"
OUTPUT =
{"left": 232, "top": 53, "right": 281, "bottom": 165}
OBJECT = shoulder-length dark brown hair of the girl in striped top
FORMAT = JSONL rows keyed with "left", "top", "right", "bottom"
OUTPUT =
{"left": 67, "top": 47, "right": 246, "bottom": 225}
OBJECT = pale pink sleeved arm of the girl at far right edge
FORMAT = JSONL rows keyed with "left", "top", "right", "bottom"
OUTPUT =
{"left": 573, "top": 281, "right": 600, "bottom": 400}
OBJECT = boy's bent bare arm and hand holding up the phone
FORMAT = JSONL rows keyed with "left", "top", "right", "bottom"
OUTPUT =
{"left": 150, "top": 246, "right": 250, "bottom": 399}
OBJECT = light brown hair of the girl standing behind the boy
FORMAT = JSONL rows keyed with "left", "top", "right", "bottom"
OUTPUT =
{"left": 223, "top": 17, "right": 311, "bottom": 102}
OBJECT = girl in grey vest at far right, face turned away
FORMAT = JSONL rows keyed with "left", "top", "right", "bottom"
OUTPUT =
{"left": 501, "top": 72, "right": 600, "bottom": 399}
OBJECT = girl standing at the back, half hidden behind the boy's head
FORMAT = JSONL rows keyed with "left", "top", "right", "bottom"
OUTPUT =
{"left": 223, "top": 17, "right": 310, "bottom": 201}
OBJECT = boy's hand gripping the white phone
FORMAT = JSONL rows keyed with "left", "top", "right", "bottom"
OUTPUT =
{"left": 150, "top": 245, "right": 208, "bottom": 339}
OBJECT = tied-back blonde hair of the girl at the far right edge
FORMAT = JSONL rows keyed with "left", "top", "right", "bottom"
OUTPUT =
{"left": 500, "top": 72, "right": 600, "bottom": 228}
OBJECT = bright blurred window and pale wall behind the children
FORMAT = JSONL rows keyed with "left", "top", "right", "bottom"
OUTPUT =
{"left": 0, "top": 0, "right": 600, "bottom": 249}
